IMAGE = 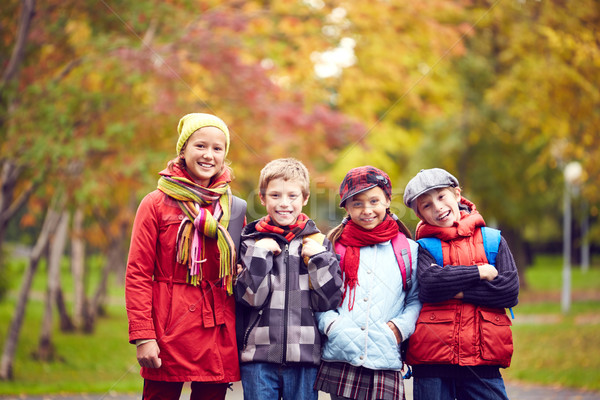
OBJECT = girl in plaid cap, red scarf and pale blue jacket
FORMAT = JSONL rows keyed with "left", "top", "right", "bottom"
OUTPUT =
{"left": 315, "top": 166, "right": 421, "bottom": 400}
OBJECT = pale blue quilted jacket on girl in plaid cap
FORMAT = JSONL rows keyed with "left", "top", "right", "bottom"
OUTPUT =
{"left": 317, "top": 239, "right": 421, "bottom": 370}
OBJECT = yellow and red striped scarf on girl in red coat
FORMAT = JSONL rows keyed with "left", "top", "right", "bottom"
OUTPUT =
{"left": 158, "top": 171, "right": 236, "bottom": 295}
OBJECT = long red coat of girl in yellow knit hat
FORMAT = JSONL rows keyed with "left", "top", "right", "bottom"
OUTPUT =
{"left": 125, "top": 167, "right": 240, "bottom": 383}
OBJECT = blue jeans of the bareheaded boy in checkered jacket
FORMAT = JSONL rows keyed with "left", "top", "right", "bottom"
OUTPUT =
{"left": 240, "top": 363, "right": 319, "bottom": 400}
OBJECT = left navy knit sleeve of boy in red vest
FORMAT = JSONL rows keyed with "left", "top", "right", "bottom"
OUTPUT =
{"left": 417, "top": 246, "right": 481, "bottom": 303}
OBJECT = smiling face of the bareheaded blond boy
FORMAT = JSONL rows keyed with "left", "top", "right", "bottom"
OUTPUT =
{"left": 260, "top": 178, "right": 309, "bottom": 226}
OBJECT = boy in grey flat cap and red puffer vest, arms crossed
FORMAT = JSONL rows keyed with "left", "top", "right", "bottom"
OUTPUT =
{"left": 404, "top": 168, "right": 519, "bottom": 400}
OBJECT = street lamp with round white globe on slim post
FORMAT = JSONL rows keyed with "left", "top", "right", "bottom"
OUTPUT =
{"left": 561, "top": 161, "right": 583, "bottom": 314}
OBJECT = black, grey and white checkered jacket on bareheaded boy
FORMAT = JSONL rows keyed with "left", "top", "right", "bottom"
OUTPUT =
{"left": 234, "top": 220, "right": 342, "bottom": 365}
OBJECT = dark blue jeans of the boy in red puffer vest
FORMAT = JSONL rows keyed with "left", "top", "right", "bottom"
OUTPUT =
{"left": 413, "top": 378, "right": 508, "bottom": 400}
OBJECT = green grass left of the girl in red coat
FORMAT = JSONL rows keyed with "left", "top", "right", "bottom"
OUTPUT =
{"left": 0, "top": 301, "right": 141, "bottom": 394}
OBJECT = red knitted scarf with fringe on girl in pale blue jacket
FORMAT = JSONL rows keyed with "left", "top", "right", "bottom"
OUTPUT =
{"left": 337, "top": 215, "right": 400, "bottom": 310}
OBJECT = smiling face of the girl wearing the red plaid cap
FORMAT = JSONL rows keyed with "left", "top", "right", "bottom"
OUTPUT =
{"left": 344, "top": 186, "right": 390, "bottom": 230}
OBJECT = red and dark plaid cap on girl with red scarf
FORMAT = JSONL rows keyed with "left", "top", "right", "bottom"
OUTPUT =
{"left": 340, "top": 165, "right": 392, "bottom": 207}
